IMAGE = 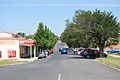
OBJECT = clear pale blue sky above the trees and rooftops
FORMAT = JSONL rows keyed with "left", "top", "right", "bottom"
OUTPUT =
{"left": 0, "top": 0, "right": 120, "bottom": 36}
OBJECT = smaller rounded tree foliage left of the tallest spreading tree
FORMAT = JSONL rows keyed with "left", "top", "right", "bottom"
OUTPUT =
{"left": 60, "top": 18, "right": 91, "bottom": 47}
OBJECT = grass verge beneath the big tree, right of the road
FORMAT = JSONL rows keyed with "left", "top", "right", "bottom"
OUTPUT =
{"left": 97, "top": 55, "right": 120, "bottom": 69}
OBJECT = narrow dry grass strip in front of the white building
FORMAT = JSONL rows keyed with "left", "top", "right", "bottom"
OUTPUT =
{"left": 0, "top": 59, "right": 28, "bottom": 65}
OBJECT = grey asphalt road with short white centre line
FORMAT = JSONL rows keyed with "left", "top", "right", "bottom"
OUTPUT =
{"left": 0, "top": 41, "right": 120, "bottom": 80}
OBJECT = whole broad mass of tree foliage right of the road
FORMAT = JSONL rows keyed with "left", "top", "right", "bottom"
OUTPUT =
{"left": 61, "top": 9, "right": 120, "bottom": 51}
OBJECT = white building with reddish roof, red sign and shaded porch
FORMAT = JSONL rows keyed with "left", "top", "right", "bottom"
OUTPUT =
{"left": 0, "top": 32, "right": 36, "bottom": 59}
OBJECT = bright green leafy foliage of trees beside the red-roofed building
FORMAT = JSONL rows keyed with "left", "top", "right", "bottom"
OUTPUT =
{"left": 34, "top": 23, "right": 57, "bottom": 49}
